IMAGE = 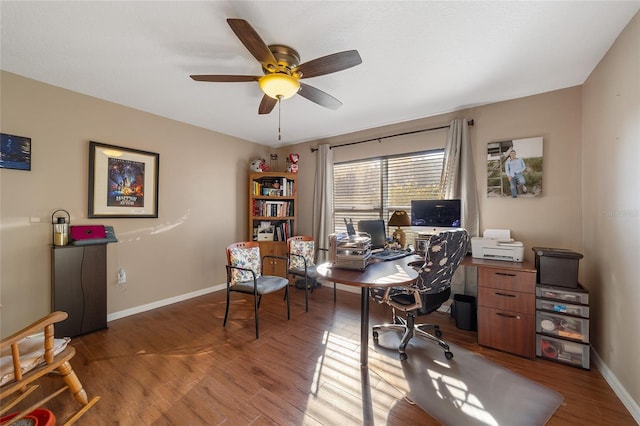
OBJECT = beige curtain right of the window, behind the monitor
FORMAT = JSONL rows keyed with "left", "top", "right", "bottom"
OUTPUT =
{"left": 440, "top": 118, "right": 480, "bottom": 236}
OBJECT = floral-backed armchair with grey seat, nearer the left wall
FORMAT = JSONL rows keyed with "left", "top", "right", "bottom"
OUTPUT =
{"left": 223, "top": 241, "right": 291, "bottom": 339}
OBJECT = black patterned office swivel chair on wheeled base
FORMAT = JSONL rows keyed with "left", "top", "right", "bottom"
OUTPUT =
{"left": 371, "top": 229, "right": 469, "bottom": 360}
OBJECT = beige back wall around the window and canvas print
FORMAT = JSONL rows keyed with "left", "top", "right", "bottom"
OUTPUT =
{"left": 291, "top": 87, "right": 582, "bottom": 259}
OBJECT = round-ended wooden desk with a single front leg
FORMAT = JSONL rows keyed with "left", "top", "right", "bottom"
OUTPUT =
{"left": 317, "top": 256, "right": 423, "bottom": 368}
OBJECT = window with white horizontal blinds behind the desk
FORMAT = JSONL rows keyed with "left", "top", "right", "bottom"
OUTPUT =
{"left": 333, "top": 149, "right": 444, "bottom": 241}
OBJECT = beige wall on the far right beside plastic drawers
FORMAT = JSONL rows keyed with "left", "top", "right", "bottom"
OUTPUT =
{"left": 582, "top": 14, "right": 640, "bottom": 406}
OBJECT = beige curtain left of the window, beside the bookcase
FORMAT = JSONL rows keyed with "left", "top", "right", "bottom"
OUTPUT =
{"left": 312, "top": 144, "right": 333, "bottom": 248}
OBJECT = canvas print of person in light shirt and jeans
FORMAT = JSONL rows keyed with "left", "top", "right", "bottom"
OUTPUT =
{"left": 487, "top": 137, "right": 542, "bottom": 198}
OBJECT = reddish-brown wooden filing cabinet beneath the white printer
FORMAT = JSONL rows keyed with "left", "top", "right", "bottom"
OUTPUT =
{"left": 476, "top": 261, "right": 536, "bottom": 358}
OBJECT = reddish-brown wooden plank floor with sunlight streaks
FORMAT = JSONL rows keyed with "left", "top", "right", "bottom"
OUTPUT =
{"left": 20, "top": 287, "right": 636, "bottom": 425}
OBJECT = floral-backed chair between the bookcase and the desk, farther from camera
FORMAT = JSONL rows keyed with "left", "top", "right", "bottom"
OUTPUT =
{"left": 287, "top": 235, "right": 336, "bottom": 312}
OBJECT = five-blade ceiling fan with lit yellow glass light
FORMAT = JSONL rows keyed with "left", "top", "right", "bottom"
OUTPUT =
{"left": 191, "top": 18, "right": 362, "bottom": 114}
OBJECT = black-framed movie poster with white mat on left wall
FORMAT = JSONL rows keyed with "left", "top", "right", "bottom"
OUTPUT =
{"left": 89, "top": 142, "right": 160, "bottom": 218}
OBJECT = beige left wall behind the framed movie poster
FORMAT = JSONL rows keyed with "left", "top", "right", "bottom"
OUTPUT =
{"left": 0, "top": 72, "right": 272, "bottom": 335}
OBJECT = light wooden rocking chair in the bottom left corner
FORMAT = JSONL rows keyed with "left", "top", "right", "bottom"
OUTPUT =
{"left": 0, "top": 311, "right": 100, "bottom": 425}
